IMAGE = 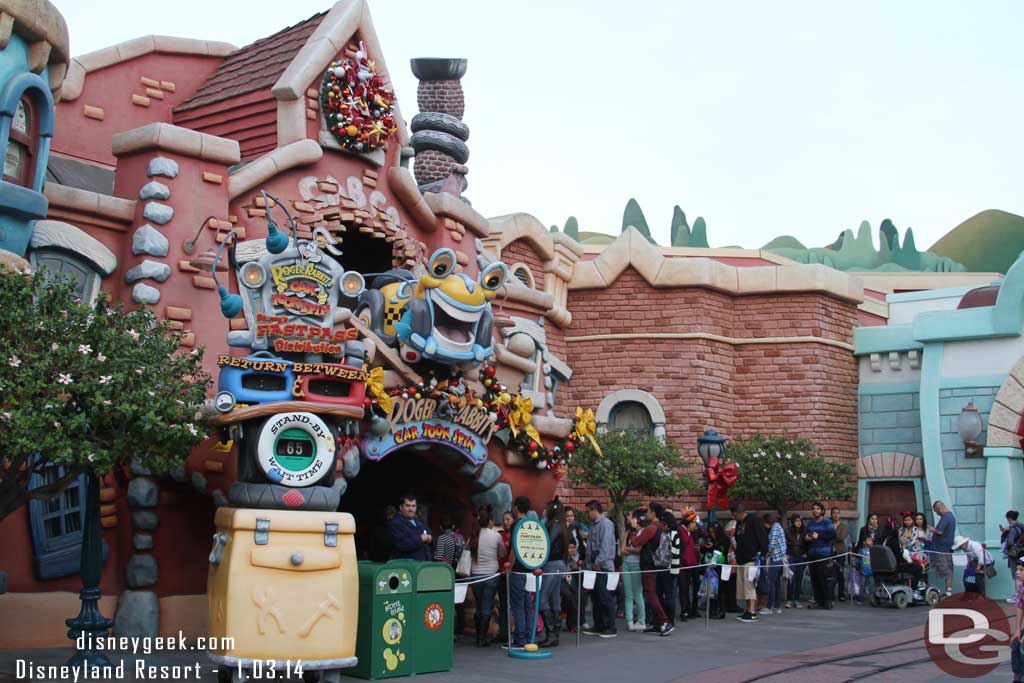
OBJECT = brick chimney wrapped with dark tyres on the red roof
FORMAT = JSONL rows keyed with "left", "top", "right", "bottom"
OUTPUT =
{"left": 410, "top": 58, "right": 469, "bottom": 197}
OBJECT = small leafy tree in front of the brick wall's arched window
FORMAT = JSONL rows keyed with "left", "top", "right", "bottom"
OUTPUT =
{"left": 569, "top": 432, "right": 697, "bottom": 533}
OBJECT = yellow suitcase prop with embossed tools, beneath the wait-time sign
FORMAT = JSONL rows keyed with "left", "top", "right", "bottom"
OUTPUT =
{"left": 207, "top": 508, "right": 359, "bottom": 680}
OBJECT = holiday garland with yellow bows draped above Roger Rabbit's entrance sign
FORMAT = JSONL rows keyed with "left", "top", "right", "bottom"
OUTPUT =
{"left": 362, "top": 365, "right": 601, "bottom": 477}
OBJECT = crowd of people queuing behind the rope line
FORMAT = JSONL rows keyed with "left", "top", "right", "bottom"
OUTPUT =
{"left": 378, "top": 495, "right": 1024, "bottom": 647}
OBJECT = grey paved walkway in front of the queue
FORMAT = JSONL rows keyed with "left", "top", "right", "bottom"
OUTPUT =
{"left": 0, "top": 605, "right": 1012, "bottom": 683}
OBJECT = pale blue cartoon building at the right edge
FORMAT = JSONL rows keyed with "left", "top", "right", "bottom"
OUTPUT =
{"left": 855, "top": 260, "right": 1024, "bottom": 594}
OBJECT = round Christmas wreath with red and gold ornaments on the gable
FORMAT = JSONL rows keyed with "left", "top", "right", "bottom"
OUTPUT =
{"left": 321, "top": 42, "right": 398, "bottom": 152}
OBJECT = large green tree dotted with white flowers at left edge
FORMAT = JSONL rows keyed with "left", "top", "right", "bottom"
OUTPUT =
{"left": 0, "top": 270, "right": 210, "bottom": 519}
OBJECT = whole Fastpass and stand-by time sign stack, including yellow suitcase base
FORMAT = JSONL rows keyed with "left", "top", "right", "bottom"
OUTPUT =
{"left": 199, "top": 193, "right": 367, "bottom": 682}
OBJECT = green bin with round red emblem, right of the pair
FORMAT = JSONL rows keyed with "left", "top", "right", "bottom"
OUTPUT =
{"left": 412, "top": 562, "right": 455, "bottom": 674}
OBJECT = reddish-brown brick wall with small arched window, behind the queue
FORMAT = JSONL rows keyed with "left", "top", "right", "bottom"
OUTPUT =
{"left": 558, "top": 268, "right": 857, "bottom": 516}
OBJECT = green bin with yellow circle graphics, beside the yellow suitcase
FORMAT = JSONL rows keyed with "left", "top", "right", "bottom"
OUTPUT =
{"left": 345, "top": 562, "right": 413, "bottom": 679}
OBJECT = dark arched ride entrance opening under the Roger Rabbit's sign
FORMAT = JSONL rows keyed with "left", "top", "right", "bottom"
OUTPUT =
{"left": 339, "top": 443, "right": 475, "bottom": 561}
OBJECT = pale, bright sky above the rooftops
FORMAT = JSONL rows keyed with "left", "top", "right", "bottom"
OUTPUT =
{"left": 52, "top": 0, "right": 1024, "bottom": 248}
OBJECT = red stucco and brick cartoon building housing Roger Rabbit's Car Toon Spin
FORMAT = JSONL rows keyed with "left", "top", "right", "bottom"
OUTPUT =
{"left": 0, "top": 0, "right": 1012, "bottom": 646}
